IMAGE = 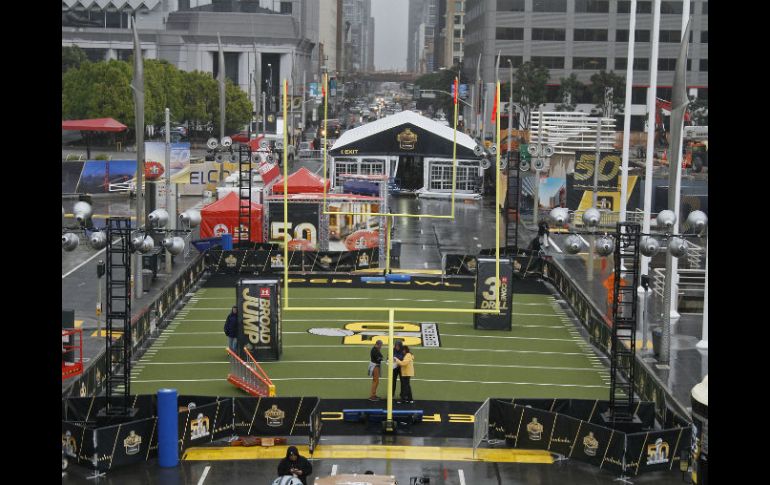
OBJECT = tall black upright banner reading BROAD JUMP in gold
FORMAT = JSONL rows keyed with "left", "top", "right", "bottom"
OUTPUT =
{"left": 236, "top": 278, "right": 282, "bottom": 362}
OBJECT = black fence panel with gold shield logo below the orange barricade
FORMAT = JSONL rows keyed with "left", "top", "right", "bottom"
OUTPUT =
{"left": 233, "top": 397, "right": 320, "bottom": 439}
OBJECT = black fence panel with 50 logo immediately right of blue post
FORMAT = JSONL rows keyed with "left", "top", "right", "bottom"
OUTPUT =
{"left": 178, "top": 399, "right": 233, "bottom": 453}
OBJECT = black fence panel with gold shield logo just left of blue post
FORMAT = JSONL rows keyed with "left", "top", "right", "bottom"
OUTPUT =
{"left": 96, "top": 417, "right": 158, "bottom": 471}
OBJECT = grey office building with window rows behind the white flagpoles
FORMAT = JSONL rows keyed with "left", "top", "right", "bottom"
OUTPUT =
{"left": 464, "top": 0, "right": 708, "bottom": 93}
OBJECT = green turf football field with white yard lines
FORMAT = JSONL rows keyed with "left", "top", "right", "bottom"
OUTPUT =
{"left": 131, "top": 288, "right": 609, "bottom": 401}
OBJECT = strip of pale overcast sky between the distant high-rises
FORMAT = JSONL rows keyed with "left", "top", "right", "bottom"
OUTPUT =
{"left": 372, "top": 0, "right": 409, "bottom": 71}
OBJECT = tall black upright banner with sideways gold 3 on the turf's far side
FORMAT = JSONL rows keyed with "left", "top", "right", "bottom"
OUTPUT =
{"left": 473, "top": 257, "right": 513, "bottom": 330}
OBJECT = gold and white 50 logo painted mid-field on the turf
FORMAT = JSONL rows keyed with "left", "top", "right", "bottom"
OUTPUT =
{"left": 308, "top": 322, "right": 441, "bottom": 347}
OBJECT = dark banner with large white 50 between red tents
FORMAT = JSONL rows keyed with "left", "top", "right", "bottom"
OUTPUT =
{"left": 265, "top": 199, "right": 320, "bottom": 251}
